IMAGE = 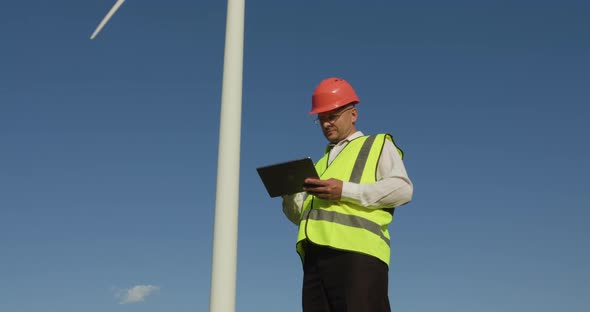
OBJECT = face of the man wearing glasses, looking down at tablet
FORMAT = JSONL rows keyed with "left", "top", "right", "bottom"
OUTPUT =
{"left": 318, "top": 105, "right": 358, "bottom": 143}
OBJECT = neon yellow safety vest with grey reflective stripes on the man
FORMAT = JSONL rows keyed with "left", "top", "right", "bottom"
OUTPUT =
{"left": 297, "top": 134, "right": 403, "bottom": 265}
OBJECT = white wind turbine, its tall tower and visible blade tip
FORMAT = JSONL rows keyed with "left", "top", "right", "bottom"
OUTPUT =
{"left": 90, "top": 0, "right": 245, "bottom": 312}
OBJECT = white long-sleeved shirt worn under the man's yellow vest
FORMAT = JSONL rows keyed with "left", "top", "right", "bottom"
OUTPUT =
{"left": 283, "top": 131, "right": 414, "bottom": 225}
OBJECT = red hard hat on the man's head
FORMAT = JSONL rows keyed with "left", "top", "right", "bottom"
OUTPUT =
{"left": 309, "top": 77, "right": 360, "bottom": 115}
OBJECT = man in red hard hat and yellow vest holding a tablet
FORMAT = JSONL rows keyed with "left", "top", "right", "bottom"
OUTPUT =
{"left": 283, "top": 78, "right": 413, "bottom": 312}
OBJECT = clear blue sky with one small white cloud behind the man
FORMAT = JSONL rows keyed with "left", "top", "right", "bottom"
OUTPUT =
{"left": 0, "top": 0, "right": 590, "bottom": 312}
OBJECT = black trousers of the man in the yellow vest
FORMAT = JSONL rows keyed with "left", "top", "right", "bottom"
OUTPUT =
{"left": 303, "top": 242, "right": 391, "bottom": 312}
